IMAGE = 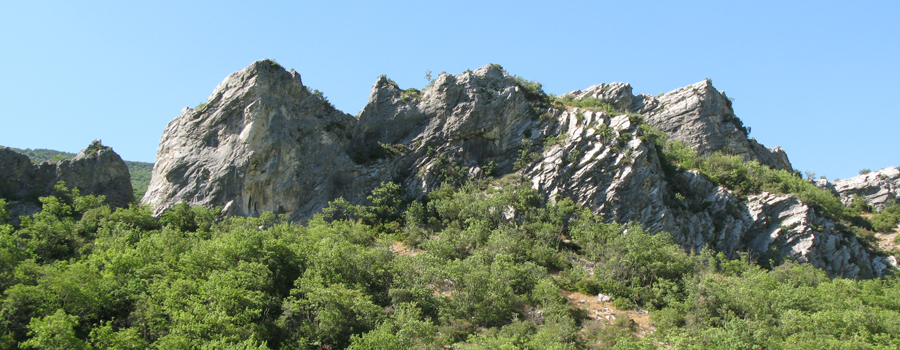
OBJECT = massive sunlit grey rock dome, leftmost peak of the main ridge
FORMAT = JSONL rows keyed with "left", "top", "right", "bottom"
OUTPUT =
{"left": 142, "top": 60, "right": 362, "bottom": 218}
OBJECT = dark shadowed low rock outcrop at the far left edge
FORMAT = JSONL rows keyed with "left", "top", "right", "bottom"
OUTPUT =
{"left": 0, "top": 141, "right": 134, "bottom": 218}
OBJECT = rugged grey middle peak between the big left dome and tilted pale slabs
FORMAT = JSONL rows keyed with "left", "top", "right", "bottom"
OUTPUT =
{"left": 376, "top": 65, "right": 549, "bottom": 197}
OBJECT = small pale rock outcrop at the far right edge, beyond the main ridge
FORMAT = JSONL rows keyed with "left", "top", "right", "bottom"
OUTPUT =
{"left": 833, "top": 167, "right": 900, "bottom": 210}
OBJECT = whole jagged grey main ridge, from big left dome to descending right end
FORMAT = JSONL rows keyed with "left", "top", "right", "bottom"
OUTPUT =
{"left": 142, "top": 60, "right": 887, "bottom": 278}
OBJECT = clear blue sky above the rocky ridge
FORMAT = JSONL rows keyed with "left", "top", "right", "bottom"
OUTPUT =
{"left": 0, "top": 0, "right": 900, "bottom": 179}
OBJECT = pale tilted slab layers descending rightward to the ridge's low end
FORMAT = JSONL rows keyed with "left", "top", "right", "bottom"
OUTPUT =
{"left": 523, "top": 113, "right": 880, "bottom": 278}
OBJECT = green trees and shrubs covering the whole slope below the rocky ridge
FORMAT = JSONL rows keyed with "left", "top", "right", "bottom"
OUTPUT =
{"left": 0, "top": 166, "right": 900, "bottom": 349}
